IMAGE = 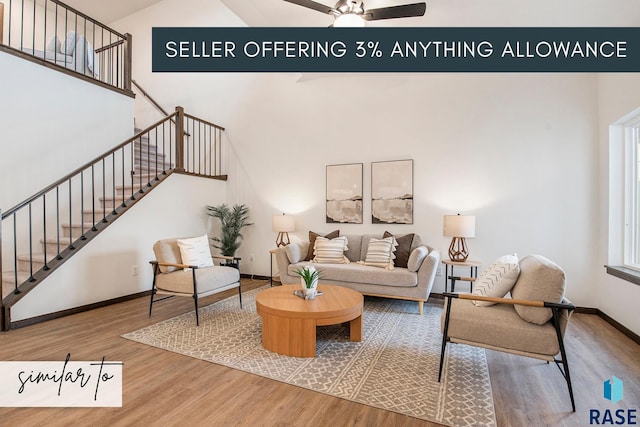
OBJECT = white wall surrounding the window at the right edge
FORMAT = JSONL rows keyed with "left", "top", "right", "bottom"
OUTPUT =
{"left": 596, "top": 74, "right": 640, "bottom": 334}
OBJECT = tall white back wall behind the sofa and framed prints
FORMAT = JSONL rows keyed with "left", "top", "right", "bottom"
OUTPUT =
{"left": 113, "top": 0, "right": 599, "bottom": 306}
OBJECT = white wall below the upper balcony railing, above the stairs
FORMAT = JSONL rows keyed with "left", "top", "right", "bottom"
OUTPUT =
{"left": 0, "top": 52, "right": 133, "bottom": 210}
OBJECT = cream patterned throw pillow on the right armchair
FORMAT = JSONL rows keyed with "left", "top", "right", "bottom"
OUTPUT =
{"left": 472, "top": 254, "right": 520, "bottom": 307}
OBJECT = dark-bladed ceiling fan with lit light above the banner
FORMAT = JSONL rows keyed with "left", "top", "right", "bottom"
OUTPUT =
{"left": 284, "top": 0, "right": 427, "bottom": 27}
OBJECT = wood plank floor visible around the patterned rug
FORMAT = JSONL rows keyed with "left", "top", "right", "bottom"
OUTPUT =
{"left": 0, "top": 280, "right": 640, "bottom": 427}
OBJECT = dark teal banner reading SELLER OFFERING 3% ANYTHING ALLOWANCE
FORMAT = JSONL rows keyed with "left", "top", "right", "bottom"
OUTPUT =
{"left": 152, "top": 27, "right": 640, "bottom": 72}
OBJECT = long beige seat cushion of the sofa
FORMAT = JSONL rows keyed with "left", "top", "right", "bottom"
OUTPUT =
{"left": 288, "top": 262, "right": 418, "bottom": 287}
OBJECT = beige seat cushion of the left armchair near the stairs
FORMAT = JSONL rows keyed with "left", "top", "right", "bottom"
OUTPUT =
{"left": 156, "top": 266, "right": 240, "bottom": 295}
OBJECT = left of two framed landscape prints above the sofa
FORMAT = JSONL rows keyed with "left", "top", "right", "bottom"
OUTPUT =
{"left": 326, "top": 163, "right": 362, "bottom": 224}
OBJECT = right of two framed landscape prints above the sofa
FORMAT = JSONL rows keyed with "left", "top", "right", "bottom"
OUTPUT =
{"left": 371, "top": 160, "right": 413, "bottom": 224}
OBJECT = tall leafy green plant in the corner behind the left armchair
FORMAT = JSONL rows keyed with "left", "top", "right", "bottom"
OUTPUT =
{"left": 207, "top": 203, "right": 253, "bottom": 264}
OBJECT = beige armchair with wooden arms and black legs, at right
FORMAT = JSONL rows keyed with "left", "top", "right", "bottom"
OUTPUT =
{"left": 438, "top": 255, "right": 576, "bottom": 412}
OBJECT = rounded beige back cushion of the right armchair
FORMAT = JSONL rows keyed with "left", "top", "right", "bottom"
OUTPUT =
{"left": 511, "top": 255, "right": 566, "bottom": 325}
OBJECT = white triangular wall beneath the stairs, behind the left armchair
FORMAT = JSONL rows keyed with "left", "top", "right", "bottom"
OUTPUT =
{"left": 11, "top": 174, "right": 226, "bottom": 321}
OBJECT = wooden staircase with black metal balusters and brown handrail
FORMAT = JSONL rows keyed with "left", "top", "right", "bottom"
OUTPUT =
{"left": 0, "top": 107, "right": 227, "bottom": 330}
